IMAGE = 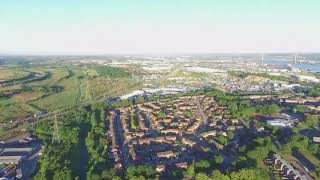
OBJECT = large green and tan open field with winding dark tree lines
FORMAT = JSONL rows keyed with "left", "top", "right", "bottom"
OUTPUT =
{"left": 0, "top": 65, "right": 140, "bottom": 122}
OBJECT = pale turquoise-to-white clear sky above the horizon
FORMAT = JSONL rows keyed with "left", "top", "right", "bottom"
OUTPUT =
{"left": 0, "top": 0, "right": 320, "bottom": 54}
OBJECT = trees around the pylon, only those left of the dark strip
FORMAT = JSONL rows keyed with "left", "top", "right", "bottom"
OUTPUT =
{"left": 34, "top": 109, "right": 87, "bottom": 180}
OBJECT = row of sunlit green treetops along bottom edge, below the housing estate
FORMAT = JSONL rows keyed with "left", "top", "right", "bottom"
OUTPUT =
{"left": 124, "top": 156, "right": 270, "bottom": 180}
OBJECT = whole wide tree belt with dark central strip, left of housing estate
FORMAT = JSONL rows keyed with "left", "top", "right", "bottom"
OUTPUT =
{"left": 34, "top": 104, "right": 118, "bottom": 180}
